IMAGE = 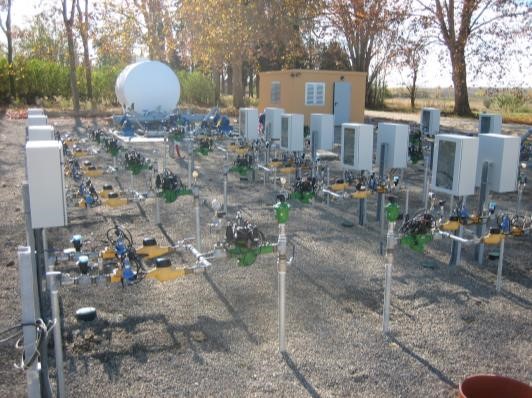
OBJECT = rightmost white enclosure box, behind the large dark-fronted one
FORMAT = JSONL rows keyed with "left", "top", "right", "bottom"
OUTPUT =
{"left": 477, "top": 134, "right": 521, "bottom": 193}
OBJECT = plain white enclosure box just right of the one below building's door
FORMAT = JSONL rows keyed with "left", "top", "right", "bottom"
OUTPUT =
{"left": 376, "top": 123, "right": 410, "bottom": 170}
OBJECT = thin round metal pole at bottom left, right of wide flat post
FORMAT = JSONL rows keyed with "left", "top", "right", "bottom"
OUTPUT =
{"left": 46, "top": 271, "right": 66, "bottom": 398}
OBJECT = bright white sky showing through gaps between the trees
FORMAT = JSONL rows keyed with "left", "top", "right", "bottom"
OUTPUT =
{"left": 7, "top": 0, "right": 532, "bottom": 88}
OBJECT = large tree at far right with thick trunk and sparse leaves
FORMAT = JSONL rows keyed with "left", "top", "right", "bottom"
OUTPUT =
{"left": 416, "top": 0, "right": 532, "bottom": 116}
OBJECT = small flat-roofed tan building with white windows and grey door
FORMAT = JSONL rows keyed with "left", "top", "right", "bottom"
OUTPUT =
{"left": 259, "top": 69, "right": 366, "bottom": 126}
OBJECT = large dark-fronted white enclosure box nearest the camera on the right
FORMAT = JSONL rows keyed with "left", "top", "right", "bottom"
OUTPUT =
{"left": 431, "top": 134, "right": 478, "bottom": 196}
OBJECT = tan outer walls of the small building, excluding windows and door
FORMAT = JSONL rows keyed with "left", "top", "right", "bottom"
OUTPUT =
{"left": 259, "top": 70, "right": 366, "bottom": 125}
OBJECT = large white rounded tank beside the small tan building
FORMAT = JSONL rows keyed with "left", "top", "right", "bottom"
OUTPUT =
{"left": 115, "top": 61, "right": 181, "bottom": 113}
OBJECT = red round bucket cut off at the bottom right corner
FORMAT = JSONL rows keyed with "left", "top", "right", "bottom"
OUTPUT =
{"left": 459, "top": 375, "right": 532, "bottom": 398}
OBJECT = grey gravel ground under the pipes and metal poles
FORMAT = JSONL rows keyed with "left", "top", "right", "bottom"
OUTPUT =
{"left": 0, "top": 110, "right": 532, "bottom": 397}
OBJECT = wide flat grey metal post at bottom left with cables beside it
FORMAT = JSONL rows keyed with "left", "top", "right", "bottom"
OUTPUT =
{"left": 18, "top": 246, "right": 41, "bottom": 398}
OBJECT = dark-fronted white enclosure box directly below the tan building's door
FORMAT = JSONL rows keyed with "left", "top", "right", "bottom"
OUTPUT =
{"left": 340, "top": 123, "right": 373, "bottom": 171}
